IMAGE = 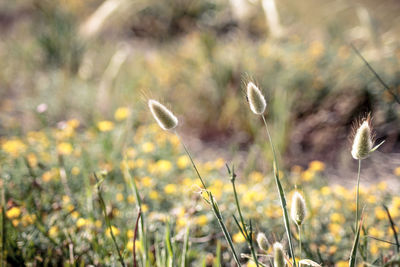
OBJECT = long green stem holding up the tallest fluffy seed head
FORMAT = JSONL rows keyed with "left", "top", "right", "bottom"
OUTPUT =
{"left": 261, "top": 115, "right": 297, "bottom": 266}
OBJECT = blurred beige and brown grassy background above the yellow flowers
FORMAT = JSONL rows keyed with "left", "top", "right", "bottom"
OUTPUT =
{"left": 0, "top": 0, "right": 400, "bottom": 182}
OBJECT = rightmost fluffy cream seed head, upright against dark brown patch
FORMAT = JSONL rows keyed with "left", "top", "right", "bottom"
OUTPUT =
{"left": 351, "top": 117, "right": 373, "bottom": 160}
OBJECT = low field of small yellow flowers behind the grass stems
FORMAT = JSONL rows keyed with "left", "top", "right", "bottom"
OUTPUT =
{"left": 1, "top": 102, "right": 400, "bottom": 266}
